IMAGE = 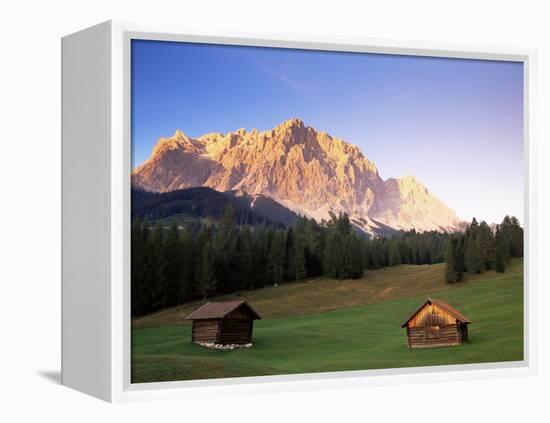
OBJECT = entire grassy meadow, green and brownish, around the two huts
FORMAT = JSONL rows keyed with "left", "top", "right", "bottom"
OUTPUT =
{"left": 132, "top": 259, "right": 523, "bottom": 383}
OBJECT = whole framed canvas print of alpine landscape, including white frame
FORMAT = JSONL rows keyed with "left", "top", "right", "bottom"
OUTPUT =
{"left": 62, "top": 22, "right": 536, "bottom": 401}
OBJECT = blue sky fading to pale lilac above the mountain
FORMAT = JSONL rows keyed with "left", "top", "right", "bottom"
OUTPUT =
{"left": 131, "top": 40, "right": 523, "bottom": 223}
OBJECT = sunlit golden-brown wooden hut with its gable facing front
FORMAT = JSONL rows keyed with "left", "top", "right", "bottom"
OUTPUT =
{"left": 401, "top": 298, "right": 471, "bottom": 348}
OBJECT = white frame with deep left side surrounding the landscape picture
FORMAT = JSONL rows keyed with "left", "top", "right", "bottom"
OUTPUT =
{"left": 62, "top": 21, "right": 537, "bottom": 402}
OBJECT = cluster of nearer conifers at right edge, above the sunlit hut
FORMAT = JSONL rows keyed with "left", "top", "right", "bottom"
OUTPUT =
{"left": 445, "top": 216, "right": 523, "bottom": 282}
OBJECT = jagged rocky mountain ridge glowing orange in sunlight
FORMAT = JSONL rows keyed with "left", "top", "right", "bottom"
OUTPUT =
{"left": 132, "top": 118, "right": 460, "bottom": 233}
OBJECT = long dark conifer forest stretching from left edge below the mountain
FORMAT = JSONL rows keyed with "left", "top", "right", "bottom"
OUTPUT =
{"left": 131, "top": 206, "right": 449, "bottom": 316}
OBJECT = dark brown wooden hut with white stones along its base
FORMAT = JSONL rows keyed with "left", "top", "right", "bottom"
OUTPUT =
{"left": 185, "top": 300, "right": 261, "bottom": 344}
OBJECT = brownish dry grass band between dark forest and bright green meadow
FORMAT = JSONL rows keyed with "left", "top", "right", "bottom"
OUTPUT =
{"left": 132, "top": 264, "right": 512, "bottom": 328}
